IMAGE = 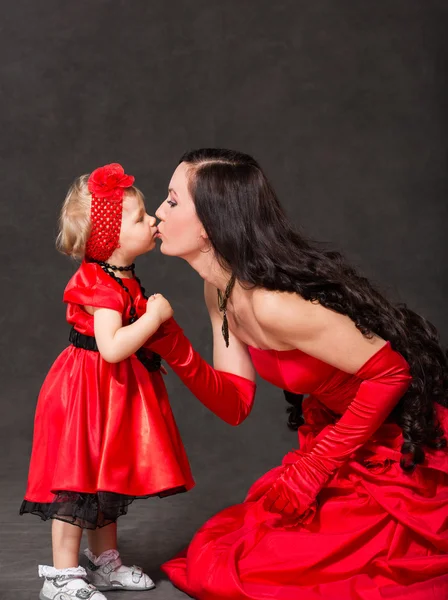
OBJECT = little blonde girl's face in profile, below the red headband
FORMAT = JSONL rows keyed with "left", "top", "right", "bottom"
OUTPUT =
{"left": 119, "top": 194, "right": 157, "bottom": 256}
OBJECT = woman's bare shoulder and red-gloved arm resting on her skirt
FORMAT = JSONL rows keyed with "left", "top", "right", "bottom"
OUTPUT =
{"left": 252, "top": 294, "right": 411, "bottom": 514}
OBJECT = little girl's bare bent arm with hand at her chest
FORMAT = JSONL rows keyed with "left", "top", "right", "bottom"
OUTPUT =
{"left": 86, "top": 294, "right": 173, "bottom": 363}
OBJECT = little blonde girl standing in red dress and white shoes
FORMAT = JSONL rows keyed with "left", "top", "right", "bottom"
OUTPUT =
{"left": 20, "top": 164, "right": 194, "bottom": 600}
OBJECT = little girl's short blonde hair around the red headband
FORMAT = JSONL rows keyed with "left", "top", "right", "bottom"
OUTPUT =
{"left": 56, "top": 175, "right": 144, "bottom": 260}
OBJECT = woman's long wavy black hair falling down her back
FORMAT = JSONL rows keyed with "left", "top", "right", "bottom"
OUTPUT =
{"left": 180, "top": 148, "right": 448, "bottom": 470}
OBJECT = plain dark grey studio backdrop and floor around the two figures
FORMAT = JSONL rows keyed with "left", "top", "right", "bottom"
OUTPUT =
{"left": 0, "top": 0, "right": 448, "bottom": 600}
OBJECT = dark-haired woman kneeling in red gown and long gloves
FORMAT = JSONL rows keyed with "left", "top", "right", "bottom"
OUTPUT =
{"left": 145, "top": 149, "right": 448, "bottom": 600}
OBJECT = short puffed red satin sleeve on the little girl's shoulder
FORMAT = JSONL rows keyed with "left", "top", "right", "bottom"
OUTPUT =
{"left": 63, "top": 262, "right": 125, "bottom": 314}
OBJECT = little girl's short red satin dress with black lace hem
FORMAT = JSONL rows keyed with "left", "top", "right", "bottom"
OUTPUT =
{"left": 21, "top": 262, "right": 194, "bottom": 528}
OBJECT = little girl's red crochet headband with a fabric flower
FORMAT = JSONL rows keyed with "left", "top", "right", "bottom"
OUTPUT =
{"left": 86, "top": 163, "right": 134, "bottom": 261}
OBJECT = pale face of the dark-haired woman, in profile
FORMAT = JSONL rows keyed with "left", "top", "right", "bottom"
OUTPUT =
{"left": 156, "top": 163, "right": 208, "bottom": 258}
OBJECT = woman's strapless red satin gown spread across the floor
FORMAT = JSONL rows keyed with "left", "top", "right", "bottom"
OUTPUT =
{"left": 163, "top": 348, "right": 448, "bottom": 600}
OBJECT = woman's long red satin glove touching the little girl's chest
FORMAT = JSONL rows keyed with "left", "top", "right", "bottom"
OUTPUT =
{"left": 144, "top": 319, "right": 256, "bottom": 425}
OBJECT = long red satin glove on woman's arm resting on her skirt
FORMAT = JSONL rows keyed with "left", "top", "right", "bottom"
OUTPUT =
{"left": 263, "top": 343, "right": 411, "bottom": 516}
